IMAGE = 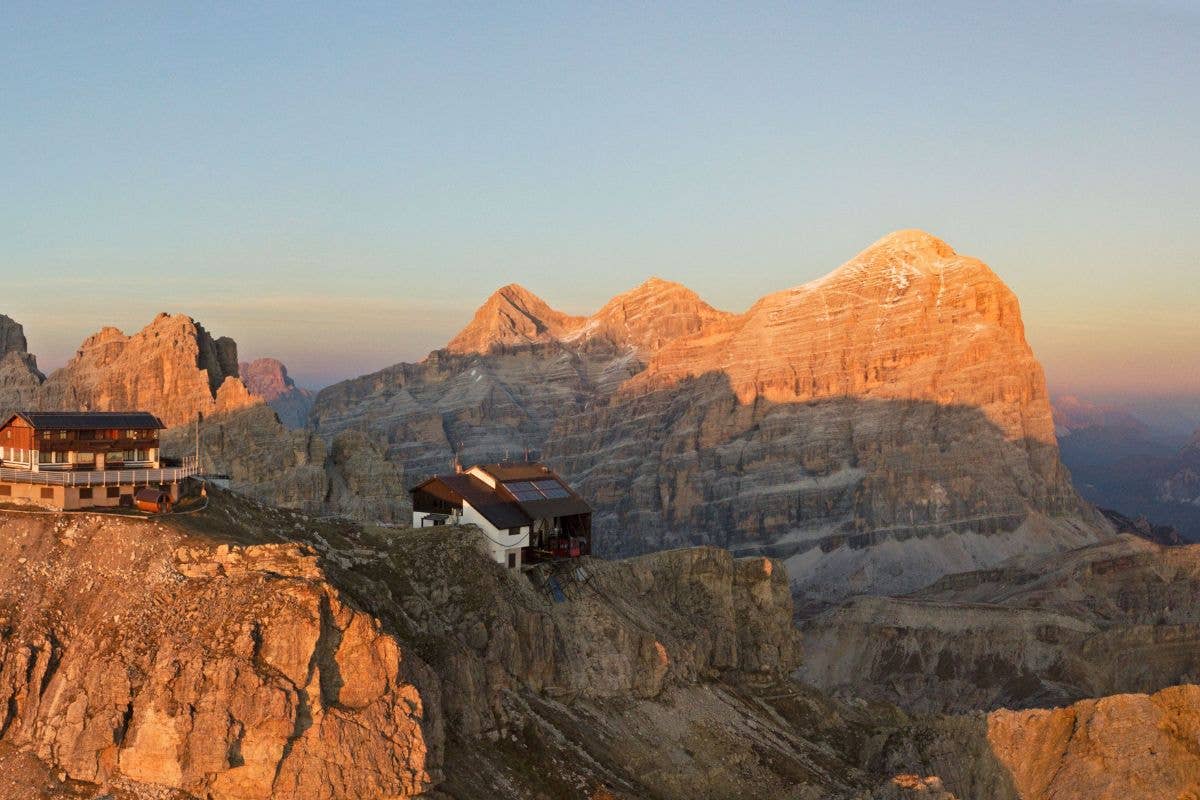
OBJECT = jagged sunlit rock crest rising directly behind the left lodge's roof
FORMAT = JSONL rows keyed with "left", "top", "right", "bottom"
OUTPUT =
{"left": 37, "top": 314, "right": 262, "bottom": 427}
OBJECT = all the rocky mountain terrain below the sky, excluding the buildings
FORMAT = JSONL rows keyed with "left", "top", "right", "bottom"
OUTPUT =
{"left": 7, "top": 230, "right": 1200, "bottom": 800}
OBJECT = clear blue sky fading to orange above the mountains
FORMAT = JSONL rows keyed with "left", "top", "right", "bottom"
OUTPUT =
{"left": 0, "top": 0, "right": 1200, "bottom": 397}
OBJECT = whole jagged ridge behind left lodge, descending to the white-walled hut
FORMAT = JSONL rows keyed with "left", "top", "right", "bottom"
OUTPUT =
{"left": 0, "top": 314, "right": 408, "bottom": 523}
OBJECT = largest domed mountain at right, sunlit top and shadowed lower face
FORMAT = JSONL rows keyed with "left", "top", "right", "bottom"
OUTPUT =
{"left": 547, "top": 231, "right": 1105, "bottom": 600}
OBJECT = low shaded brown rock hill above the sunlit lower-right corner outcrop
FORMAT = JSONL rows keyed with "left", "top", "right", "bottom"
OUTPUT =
{"left": 798, "top": 536, "right": 1200, "bottom": 712}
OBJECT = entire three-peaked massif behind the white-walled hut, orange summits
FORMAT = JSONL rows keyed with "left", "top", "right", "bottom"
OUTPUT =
{"left": 312, "top": 230, "right": 1111, "bottom": 603}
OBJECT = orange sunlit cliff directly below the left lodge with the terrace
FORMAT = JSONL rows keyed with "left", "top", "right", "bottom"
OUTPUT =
{"left": 0, "top": 516, "right": 442, "bottom": 800}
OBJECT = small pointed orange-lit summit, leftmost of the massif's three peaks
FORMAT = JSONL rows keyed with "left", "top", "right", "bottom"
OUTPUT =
{"left": 446, "top": 283, "right": 583, "bottom": 354}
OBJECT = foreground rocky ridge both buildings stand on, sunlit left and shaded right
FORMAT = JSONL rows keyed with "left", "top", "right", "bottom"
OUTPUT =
{"left": 0, "top": 489, "right": 892, "bottom": 800}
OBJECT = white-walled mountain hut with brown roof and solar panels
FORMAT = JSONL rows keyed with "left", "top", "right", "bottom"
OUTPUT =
{"left": 412, "top": 462, "right": 592, "bottom": 569}
